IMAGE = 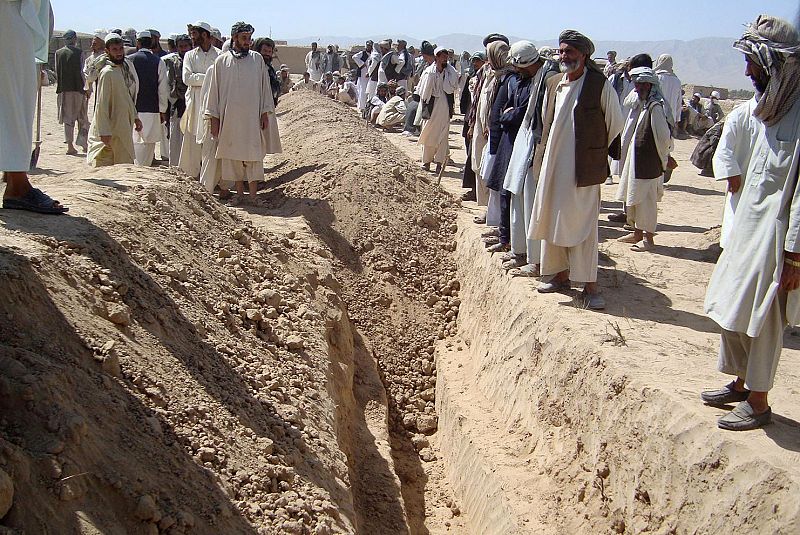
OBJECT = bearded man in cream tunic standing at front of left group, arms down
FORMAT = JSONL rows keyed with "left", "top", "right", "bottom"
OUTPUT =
{"left": 205, "top": 22, "right": 281, "bottom": 204}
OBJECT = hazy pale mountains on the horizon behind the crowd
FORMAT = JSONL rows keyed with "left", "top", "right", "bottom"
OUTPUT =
{"left": 288, "top": 33, "right": 753, "bottom": 90}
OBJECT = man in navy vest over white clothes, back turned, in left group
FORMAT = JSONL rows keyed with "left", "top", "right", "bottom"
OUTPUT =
{"left": 130, "top": 30, "right": 169, "bottom": 167}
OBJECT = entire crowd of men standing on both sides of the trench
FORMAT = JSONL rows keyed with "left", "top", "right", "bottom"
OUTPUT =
{"left": 0, "top": 2, "right": 800, "bottom": 436}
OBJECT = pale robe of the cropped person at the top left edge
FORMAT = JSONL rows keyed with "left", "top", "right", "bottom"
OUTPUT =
{"left": 0, "top": 0, "right": 50, "bottom": 172}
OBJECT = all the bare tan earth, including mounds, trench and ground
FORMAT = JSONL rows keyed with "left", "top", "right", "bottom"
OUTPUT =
{"left": 0, "top": 88, "right": 800, "bottom": 535}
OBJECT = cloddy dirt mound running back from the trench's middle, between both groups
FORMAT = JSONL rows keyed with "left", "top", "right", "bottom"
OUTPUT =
{"left": 254, "top": 92, "right": 460, "bottom": 533}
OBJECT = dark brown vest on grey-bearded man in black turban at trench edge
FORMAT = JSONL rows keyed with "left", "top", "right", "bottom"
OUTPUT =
{"left": 573, "top": 69, "right": 610, "bottom": 187}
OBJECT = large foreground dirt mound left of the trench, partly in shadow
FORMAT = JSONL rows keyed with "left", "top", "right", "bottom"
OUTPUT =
{"left": 0, "top": 174, "right": 360, "bottom": 534}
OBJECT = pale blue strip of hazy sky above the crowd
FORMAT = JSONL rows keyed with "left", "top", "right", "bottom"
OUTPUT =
{"left": 51, "top": 0, "right": 798, "bottom": 41}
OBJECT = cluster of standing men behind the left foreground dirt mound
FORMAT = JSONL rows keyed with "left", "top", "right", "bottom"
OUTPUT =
{"left": 45, "top": 21, "right": 292, "bottom": 204}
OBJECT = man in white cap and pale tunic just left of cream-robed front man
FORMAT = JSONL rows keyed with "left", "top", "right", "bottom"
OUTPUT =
{"left": 178, "top": 21, "right": 219, "bottom": 178}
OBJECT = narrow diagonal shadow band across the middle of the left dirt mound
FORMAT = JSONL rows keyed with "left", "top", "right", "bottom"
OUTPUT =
{"left": 0, "top": 212, "right": 346, "bottom": 533}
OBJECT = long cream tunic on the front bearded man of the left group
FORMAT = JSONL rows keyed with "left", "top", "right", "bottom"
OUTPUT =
{"left": 205, "top": 51, "right": 281, "bottom": 162}
